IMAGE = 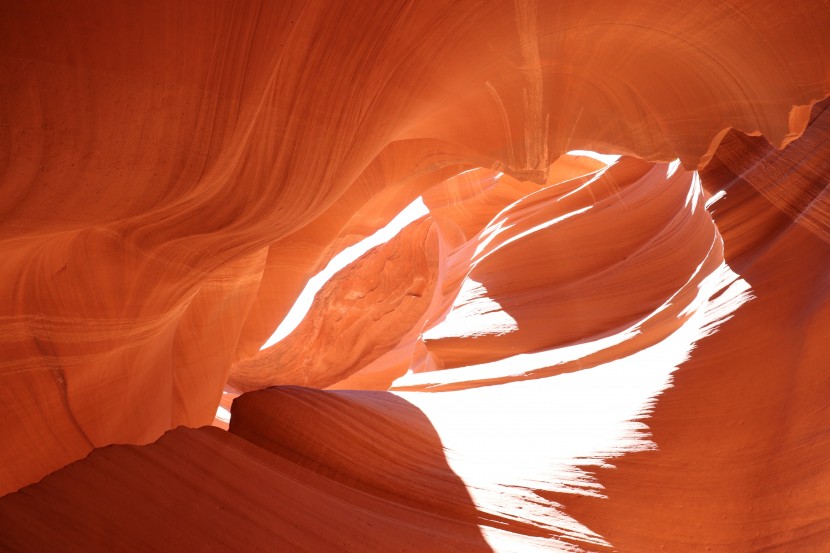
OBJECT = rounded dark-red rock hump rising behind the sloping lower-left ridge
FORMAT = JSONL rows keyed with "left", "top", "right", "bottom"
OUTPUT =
{"left": 230, "top": 386, "right": 498, "bottom": 551}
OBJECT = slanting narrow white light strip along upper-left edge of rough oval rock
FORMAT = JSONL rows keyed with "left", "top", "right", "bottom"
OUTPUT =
{"left": 259, "top": 196, "right": 429, "bottom": 351}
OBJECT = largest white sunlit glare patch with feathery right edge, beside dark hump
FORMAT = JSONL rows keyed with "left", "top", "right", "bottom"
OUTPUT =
{"left": 393, "top": 263, "right": 752, "bottom": 551}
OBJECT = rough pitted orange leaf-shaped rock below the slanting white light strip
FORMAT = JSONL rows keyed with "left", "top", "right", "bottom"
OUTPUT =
{"left": 229, "top": 221, "right": 438, "bottom": 391}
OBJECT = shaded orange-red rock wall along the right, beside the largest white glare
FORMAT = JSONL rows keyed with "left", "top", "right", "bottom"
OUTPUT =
{"left": 568, "top": 100, "right": 830, "bottom": 552}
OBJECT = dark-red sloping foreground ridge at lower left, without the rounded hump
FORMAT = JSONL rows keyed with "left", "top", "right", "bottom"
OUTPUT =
{"left": 0, "top": 419, "right": 488, "bottom": 552}
